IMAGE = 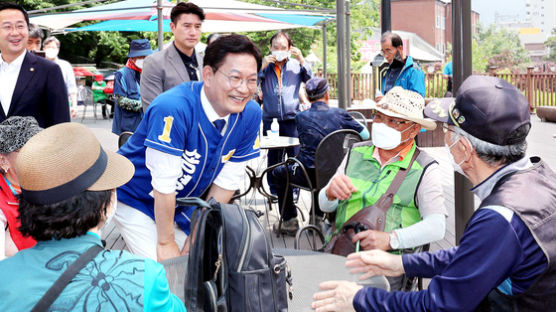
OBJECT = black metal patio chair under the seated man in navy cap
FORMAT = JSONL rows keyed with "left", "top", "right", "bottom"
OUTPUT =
{"left": 264, "top": 129, "right": 361, "bottom": 250}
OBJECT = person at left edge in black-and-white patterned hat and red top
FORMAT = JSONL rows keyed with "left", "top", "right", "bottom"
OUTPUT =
{"left": 0, "top": 116, "right": 42, "bottom": 260}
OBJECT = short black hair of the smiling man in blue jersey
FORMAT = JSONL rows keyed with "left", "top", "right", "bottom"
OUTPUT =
{"left": 203, "top": 34, "right": 262, "bottom": 72}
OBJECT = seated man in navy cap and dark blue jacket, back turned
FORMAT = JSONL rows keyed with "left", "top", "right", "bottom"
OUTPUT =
{"left": 269, "top": 78, "right": 369, "bottom": 235}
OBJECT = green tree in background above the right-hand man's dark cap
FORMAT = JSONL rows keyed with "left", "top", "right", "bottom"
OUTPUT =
{"left": 472, "top": 25, "right": 530, "bottom": 72}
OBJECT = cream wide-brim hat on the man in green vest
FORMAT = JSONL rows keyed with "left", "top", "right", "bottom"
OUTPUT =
{"left": 375, "top": 86, "right": 436, "bottom": 130}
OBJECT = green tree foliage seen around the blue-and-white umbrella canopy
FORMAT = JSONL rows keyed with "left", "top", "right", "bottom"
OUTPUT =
{"left": 19, "top": 0, "right": 380, "bottom": 72}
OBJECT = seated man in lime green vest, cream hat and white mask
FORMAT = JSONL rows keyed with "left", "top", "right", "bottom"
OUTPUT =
{"left": 319, "top": 87, "right": 447, "bottom": 290}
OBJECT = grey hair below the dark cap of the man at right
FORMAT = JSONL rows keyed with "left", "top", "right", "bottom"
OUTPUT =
{"left": 452, "top": 124, "right": 530, "bottom": 166}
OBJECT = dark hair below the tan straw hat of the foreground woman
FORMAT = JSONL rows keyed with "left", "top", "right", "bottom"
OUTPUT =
{"left": 19, "top": 190, "right": 112, "bottom": 241}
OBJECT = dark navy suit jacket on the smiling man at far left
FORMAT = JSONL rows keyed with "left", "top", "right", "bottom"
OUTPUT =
{"left": 0, "top": 52, "right": 70, "bottom": 128}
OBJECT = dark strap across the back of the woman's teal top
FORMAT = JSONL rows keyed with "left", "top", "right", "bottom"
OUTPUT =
{"left": 31, "top": 244, "right": 103, "bottom": 312}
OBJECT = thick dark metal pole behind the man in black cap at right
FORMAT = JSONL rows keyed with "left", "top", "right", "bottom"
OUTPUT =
{"left": 452, "top": 0, "right": 475, "bottom": 244}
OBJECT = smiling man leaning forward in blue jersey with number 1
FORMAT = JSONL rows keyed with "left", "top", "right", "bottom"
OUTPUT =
{"left": 115, "top": 35, "right": 262, "bottom": 261}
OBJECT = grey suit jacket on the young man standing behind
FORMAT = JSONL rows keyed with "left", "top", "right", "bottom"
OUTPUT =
{"left": 140, "top": 42, "right": 203, "bottom": 111}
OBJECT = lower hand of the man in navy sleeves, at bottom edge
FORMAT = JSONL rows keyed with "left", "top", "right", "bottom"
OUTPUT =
{"left": 311, "top": 281, "right": 363, "bottom": 312}
